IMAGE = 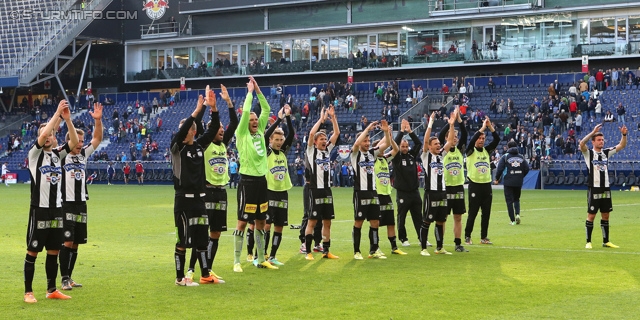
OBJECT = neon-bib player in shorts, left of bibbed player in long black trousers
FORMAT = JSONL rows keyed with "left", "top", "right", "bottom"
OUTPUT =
{"left": 438, "top": 108, "right": 469, "bottom": 252}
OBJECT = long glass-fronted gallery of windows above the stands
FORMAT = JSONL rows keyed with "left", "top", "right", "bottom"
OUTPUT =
{"left": 127, "top": 12, "right": 640, "bottom": 81}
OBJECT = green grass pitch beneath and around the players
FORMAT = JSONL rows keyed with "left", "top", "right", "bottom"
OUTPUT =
{"left": 0, "top": 185, "right": 640, "bottom": 319}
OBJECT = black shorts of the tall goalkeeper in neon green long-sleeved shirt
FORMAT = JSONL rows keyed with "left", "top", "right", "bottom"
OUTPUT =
{"left": 237, "top": 175, "right": 269, "bottom": 222}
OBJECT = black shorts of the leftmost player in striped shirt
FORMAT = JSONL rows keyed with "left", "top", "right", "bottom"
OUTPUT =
{"left": 27, "top": 206, "right": 64, "bottom": 252}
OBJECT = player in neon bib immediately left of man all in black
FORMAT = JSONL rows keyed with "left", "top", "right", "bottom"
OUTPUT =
{"left": 373, "top": 120, "right": 407, "bottom": 255}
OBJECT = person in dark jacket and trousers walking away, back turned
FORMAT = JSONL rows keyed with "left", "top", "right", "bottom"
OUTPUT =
{"left": 493, "top": 140, "right": 529, "bottom": 225}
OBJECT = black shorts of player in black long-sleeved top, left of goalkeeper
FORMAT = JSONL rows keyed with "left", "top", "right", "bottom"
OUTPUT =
{"left": 173, "top": 193, "right": 209, "bottom": 248}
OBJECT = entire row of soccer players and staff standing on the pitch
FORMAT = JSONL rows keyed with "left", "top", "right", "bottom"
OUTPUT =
{"left": 24, "top": 77, "right": 628, "bottom": 303}
